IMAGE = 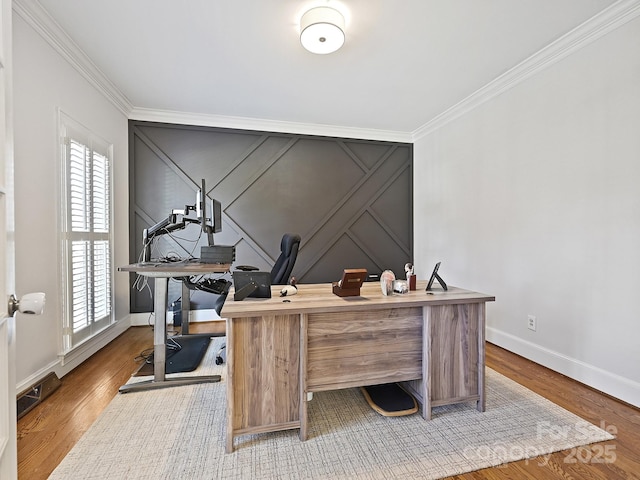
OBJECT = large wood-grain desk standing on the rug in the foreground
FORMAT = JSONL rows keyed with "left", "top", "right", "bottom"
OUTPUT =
{"left": 221, "top": 281, "right": 495, "bottom": 452}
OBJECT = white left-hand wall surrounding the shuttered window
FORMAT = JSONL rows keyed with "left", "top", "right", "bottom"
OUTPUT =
{"left": 14, "top": 15, "right": 129, "bottom": 390}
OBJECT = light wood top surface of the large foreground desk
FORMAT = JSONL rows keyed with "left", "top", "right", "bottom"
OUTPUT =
{"left": 220, "top": 280, "right": 495, "bottom": 318}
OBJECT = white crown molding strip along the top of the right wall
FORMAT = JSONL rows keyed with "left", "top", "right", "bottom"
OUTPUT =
{"left": 411, "top": 0, "right": 640, "bottom": 142}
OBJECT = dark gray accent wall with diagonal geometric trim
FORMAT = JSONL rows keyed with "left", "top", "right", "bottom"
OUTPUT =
{"left": 129, "top": 121, "right": 413, "bottom": 312}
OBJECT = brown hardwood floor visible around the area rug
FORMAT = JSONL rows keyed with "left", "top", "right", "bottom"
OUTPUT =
{"left": 18, "top": 322, "right": 640, "bottom": 480}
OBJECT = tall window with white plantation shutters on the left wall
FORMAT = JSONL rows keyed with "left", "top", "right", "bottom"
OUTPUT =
{"left": 61, "top": 114, "right": 113, "bottom": 351}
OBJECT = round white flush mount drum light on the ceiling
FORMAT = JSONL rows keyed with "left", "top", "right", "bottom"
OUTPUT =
{"left": 300, "top": 7, "right": 344, "bottom": 54}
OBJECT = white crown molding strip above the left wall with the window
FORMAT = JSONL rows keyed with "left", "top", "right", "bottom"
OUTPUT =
{"left": 13, "top": 0, "right": 133, "bottom": 117}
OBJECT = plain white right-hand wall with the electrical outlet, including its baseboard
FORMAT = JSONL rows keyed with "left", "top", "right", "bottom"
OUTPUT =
{"left": 414, "top": 18, "right": 640, "bottom": 406}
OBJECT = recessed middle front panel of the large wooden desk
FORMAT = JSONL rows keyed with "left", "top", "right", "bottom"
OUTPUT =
{"left": 306, "top": 307, "right": 423, "bottom": 391}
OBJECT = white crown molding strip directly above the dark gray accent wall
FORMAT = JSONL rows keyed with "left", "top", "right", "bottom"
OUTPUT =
{"left": 129, "top": 108, "right": 413, "bottom": 143}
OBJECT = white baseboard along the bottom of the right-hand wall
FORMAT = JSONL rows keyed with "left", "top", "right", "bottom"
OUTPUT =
{"left": 486, "top": 327, "right": 640, "bottom": 407}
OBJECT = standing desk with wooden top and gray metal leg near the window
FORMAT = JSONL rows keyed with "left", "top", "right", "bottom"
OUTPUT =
{"left": 118, "top": 260, "right": 231, "bottom": 393}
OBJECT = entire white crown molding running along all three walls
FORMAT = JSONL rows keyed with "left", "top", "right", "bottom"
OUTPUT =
{"left": 13, "top": 0, "right": 640, "bottom": 143}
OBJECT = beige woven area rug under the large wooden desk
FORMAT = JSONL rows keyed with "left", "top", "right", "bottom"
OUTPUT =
{"left": 50, "top": 338, "right": 613, "bottom": 480}
